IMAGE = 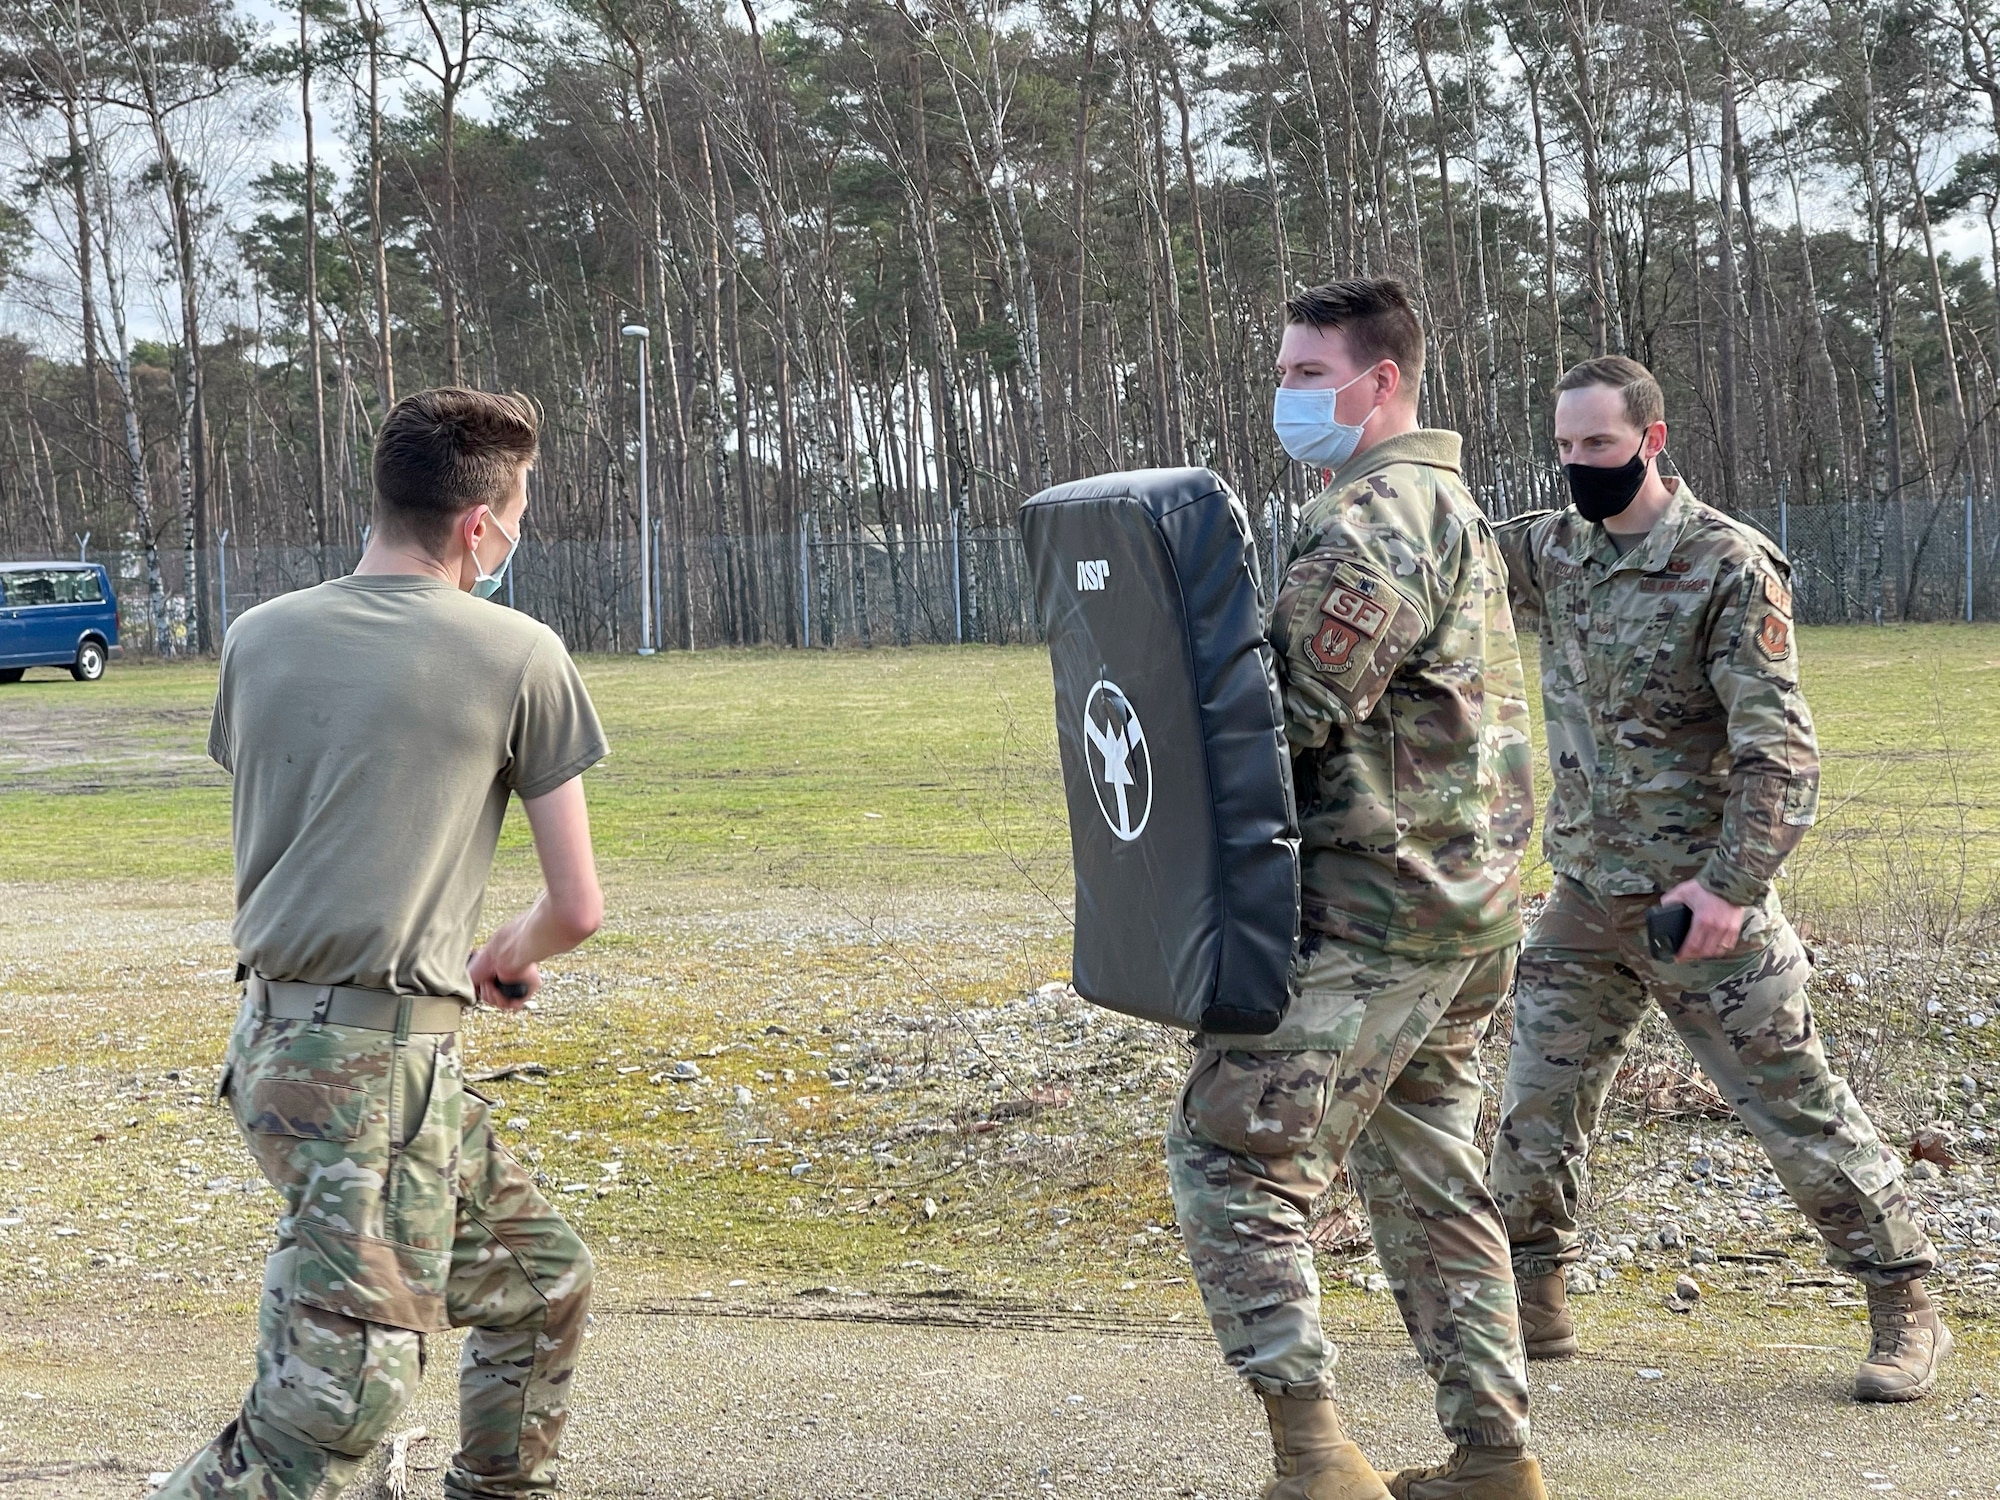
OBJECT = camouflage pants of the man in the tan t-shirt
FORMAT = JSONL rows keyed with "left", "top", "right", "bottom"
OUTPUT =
{"left": 158, "top": 1004, "right": 592, "bottom": 1500}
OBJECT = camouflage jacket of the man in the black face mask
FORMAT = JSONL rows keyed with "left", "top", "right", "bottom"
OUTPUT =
{"left": 1498, "top": 480, "right": 1820, "bottom": 906}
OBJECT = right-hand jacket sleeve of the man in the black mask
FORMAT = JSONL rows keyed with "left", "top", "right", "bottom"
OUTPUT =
{"left": 1698, "top": 556, "right": 1820, "bottom": 906}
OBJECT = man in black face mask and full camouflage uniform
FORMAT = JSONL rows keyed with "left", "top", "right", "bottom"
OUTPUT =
{"left": 1488, "top": 356, "right": 1952, "bottom": 1402}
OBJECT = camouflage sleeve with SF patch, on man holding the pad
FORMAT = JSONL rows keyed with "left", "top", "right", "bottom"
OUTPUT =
{"left": 1270, "top": 526, "right": 1436, "bottom": 750}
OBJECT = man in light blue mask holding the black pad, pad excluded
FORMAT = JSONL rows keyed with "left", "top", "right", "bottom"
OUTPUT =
{"left": 1166, "top": 280, "right": 1544, "bottom": 1500}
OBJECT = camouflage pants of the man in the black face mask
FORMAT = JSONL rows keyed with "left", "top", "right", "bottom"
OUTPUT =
{"left": 1488, "top": 878, "right": 1934, "bottom": 1286}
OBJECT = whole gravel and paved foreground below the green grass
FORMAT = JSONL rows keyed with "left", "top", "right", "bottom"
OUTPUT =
{"left": 0, "top": 888, "right": 2000, "bottom": 1500}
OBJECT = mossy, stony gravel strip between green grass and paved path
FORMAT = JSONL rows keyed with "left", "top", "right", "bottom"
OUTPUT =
{"left": 11, "top": 888, "right": 2000, "bottom": 1316}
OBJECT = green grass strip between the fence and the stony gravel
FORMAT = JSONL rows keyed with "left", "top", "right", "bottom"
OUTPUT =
{"left": 0, "top": 626, "right": 2000, "bottom": 904}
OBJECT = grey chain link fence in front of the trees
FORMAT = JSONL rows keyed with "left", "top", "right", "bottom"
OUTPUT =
{"left": 19, "top": 494, "right": 2000, "bottom": 654}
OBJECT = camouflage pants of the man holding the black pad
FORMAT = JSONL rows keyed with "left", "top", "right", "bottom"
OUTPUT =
{"left": 1166, "top": 940, "right": 1528, "bottom": 1444}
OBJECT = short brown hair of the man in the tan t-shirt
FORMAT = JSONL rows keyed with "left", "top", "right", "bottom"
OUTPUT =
{"left": 374, "top": 386, "right": 538, "bottom": 554}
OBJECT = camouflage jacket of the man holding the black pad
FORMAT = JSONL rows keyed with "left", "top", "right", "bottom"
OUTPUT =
{"left": 1270, "top": 430, "right": 1534, "bottom": 958}
